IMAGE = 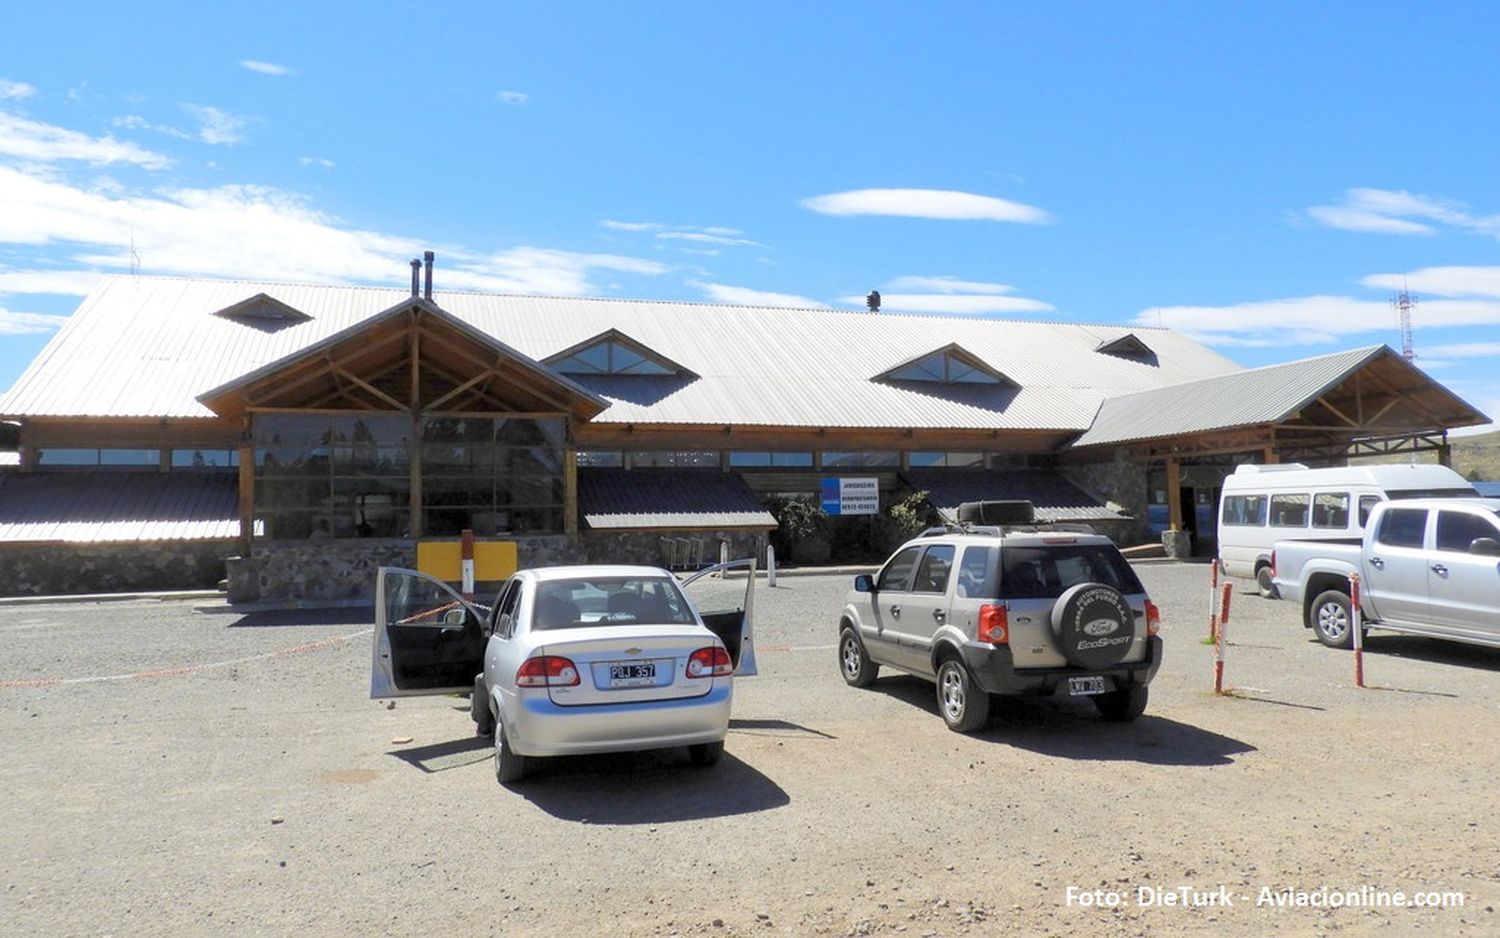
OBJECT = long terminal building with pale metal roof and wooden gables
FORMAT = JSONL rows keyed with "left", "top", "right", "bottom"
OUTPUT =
{"left": 0, "top": 267, "right": 1488, "bottom": 600}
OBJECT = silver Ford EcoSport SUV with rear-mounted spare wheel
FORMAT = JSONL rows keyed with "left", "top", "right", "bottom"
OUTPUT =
{"left": 839, "top": 507, "right": 1161, "bottom": 732}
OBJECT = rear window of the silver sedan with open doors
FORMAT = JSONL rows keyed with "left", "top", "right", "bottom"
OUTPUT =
{"left": 531, "top": 576, "right": 695, "bottom": 632}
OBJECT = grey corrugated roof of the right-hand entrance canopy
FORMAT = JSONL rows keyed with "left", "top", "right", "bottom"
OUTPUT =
{"left": 1073, "top": 345, "right": 1386, "bottom": 447}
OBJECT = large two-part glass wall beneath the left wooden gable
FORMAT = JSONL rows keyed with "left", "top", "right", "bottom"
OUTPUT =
{"left": 255, "top": 414, "right": 567, "bottom": 537}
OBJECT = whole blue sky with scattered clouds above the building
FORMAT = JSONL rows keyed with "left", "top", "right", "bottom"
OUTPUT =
{"left": 0, "top": 0, "right": 1500, "bottom": 429}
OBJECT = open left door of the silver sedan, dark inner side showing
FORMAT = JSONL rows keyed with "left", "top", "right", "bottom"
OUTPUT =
{"left": 371, "top": 567, "right": 486, "bottom": 698}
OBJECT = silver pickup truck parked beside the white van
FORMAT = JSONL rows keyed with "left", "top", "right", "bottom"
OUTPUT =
{"left": 1272, "top": 498, "right": 1500, "bottom": 648}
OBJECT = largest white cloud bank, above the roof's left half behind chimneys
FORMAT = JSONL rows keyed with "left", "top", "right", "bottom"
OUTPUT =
{"left": 0, "top": 165, "right": 668, "bottom": 296}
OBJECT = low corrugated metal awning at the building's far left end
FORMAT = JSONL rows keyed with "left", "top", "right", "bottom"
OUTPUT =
{"left": 0, "top": 471, "right": 240, "bottom": 542}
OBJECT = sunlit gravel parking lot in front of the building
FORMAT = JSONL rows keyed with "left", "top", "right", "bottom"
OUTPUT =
{"left": 0, "top": 564, "right": 1500, "bottom": 935}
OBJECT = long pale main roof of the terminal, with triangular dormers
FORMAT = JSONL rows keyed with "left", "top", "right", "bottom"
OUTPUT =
{"left": 0, "top": 276, "right": 1239, "bottom": 431}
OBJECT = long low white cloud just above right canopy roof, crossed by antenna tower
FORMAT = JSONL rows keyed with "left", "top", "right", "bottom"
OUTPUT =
{"left": 1134, "top": 296, "right": 1500, "bottom": 347}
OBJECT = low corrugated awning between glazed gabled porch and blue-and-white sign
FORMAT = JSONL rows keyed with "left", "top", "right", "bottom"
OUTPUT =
{"left": 578, "top": 468, "right": 776, "bottom": 530}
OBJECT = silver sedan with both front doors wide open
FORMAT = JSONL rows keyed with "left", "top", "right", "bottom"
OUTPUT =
{"left": 371, "top": 566, "right": 755, "bottom": 783}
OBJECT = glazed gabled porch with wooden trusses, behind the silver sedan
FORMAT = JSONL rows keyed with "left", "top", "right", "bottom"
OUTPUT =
{"left": 198, "top": 297, "right": 608, "bottom": 539}
